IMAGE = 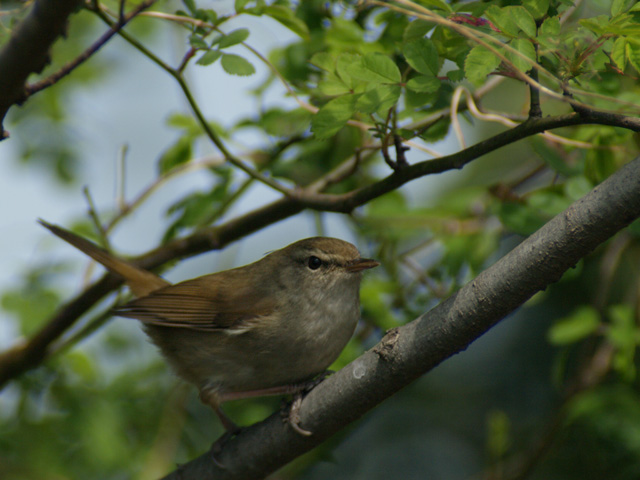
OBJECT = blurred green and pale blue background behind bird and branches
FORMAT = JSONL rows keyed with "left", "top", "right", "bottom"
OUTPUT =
{"left": 0, "top": 0, "right": 640, "bottom": 480}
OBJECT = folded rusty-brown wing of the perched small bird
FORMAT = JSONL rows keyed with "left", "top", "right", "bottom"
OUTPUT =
{"left": 114, "top": 274, "right": 276, "bottom": 334}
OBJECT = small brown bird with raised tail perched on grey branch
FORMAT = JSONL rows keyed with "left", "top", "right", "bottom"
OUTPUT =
{"left": 40, "top": 220, "right": 379, "bottom": 435}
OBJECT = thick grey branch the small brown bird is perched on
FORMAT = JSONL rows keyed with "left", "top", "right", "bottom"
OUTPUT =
{"left": 166, "top": 158, "right": 640, "bottom": 480}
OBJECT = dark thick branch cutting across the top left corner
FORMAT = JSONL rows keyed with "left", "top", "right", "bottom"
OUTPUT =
{"left": 0, "top": 0, "right": 82, "bottom": 140}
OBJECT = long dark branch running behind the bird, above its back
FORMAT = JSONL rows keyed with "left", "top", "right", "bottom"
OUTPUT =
{"left": 0, "top": 111, "right": 640, "bottom": 388}
